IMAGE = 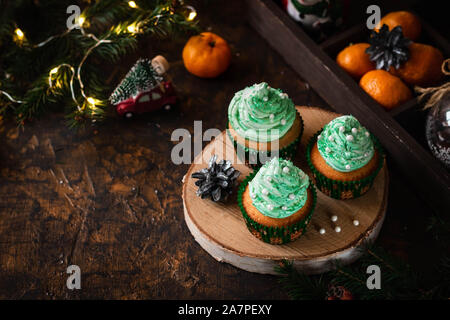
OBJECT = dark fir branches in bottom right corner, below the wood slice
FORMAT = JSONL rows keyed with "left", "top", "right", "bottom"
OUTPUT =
{"left": 275, "top": 245, "right": 450, "bottom": 300}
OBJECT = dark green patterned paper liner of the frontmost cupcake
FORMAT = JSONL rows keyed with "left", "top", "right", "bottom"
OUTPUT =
{"left": 237, "top": 170, "right": 317, "bottom": 244}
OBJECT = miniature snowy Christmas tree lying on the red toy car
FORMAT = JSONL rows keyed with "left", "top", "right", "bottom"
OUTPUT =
{"left": 109, "top": 59, "right": 163, "bottom": 105}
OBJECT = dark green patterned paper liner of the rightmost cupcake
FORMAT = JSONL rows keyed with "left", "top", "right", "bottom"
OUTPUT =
{"left": 306, "top": 129, "right": 384, "bottom": 200}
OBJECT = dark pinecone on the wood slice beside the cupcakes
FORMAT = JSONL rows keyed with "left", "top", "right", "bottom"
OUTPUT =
{"left": 192, "top": 155, "right": 241, "bottom": 201}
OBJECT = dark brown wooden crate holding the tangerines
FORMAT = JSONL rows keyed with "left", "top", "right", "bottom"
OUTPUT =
{"left": 247, "top": 0, "right": 450, "bottom": 212}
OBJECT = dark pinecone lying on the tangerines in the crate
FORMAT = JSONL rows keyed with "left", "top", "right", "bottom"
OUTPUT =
{"left": 366, "top": 24, "right": 411, "bottom": 71}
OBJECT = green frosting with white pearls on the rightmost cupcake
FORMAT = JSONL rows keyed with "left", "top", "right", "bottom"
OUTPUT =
{"left": 317, "top": 116, "right": 375, "bottom": 172}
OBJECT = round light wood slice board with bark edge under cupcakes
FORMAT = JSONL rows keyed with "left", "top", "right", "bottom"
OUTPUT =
{"left": 183, "top": 107, "right": 388, "bottom": 274}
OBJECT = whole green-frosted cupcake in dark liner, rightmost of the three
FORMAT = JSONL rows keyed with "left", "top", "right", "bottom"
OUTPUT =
{"left": 306, "top": 115, "right": 384, "bottom": 199}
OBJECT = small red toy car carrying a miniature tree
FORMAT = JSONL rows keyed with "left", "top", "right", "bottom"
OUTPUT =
{"left": 116, "top": 81, "right": 177, "bottom": 118}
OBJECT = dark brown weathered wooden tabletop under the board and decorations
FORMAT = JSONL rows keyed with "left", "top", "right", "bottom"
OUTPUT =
{"left": 0, "top": 0, "right": 442, "bottom": 299}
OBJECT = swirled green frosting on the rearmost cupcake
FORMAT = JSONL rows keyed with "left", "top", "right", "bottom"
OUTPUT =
{"left": 228, "top": 82, "right": 296, "bottom": 142}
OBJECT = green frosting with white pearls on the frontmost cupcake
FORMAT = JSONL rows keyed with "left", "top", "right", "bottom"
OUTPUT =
{"left": 249, "top": 158, "right": 309, "bottom": 218}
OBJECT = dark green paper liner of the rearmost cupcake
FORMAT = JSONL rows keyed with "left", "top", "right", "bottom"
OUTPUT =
{"left": 227, "top": 111, "right": 304, "bottom": 169}
